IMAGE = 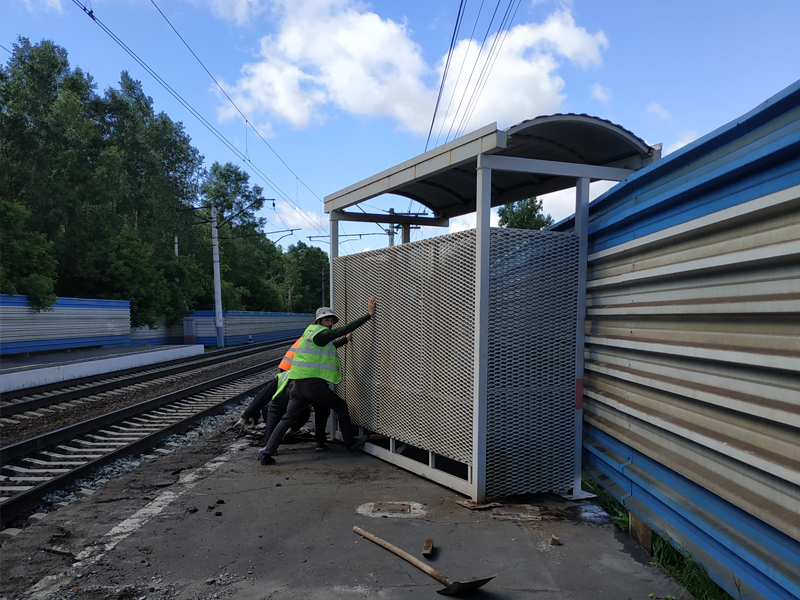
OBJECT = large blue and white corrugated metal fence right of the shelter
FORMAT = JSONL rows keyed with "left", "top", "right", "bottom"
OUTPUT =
{"left": 556, "top": 82, "right": 800, "bottom": 600}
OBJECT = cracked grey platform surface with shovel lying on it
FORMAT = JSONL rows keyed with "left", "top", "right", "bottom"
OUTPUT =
{"left": 0, "top": 424, "right": 690, "bottom": 600}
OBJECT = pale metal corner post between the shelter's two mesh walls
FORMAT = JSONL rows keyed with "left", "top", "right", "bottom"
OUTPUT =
{"left": 471, "top": 162, "right": 492, "bottom": 502}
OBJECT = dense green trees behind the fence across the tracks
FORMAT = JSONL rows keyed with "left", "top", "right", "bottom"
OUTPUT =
{"left": 0, "top": 37, "right": 328, "bottom": 326}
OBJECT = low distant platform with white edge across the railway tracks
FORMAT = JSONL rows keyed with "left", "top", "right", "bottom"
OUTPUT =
{"left": 0, "top": 344, "right": 205, "bottom": 393}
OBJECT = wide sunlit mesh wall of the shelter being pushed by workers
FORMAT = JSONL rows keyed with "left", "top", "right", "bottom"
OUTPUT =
{"left": 333, "top": 230, "right": 475, "bottom": 464}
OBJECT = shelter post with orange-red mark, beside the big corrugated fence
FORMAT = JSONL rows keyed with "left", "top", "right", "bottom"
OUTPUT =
{"left": 572, "top": 177, "right": 589, "bottom": 497}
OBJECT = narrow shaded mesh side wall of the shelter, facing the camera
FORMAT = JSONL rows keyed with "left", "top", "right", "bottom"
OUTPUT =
{"left": 486, "top": 229, "right": 578, "bottom": 496}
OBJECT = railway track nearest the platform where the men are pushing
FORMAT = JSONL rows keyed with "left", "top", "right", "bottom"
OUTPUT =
{"left": 0, "top": 359, "right": 280, "bottom": 526}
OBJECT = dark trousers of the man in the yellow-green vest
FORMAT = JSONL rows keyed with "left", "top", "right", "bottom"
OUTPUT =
{"left": 261, "top": 378, "right": 353, "bottom": 456}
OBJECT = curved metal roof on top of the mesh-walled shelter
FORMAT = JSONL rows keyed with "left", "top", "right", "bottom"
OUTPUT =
{"left": 325, "top": 114, "right": 660, "bottom": 218}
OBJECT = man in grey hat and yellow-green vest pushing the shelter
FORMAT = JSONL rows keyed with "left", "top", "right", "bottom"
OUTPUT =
{"left": 261, "top": 296, "right": 376, "bottom": 465}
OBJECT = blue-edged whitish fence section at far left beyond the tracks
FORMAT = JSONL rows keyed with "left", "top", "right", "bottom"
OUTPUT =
{"left": 0, "top": 294, "right": 131, "bottom": 354}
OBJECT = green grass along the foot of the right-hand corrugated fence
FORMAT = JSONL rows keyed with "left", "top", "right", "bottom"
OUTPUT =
{"left": 581, "top": 472, "right": 741, "bottom": 600}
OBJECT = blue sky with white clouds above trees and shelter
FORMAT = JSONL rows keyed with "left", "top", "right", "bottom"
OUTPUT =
{"left": 0, "top": 0, "right": 800, "bottom": 254}
